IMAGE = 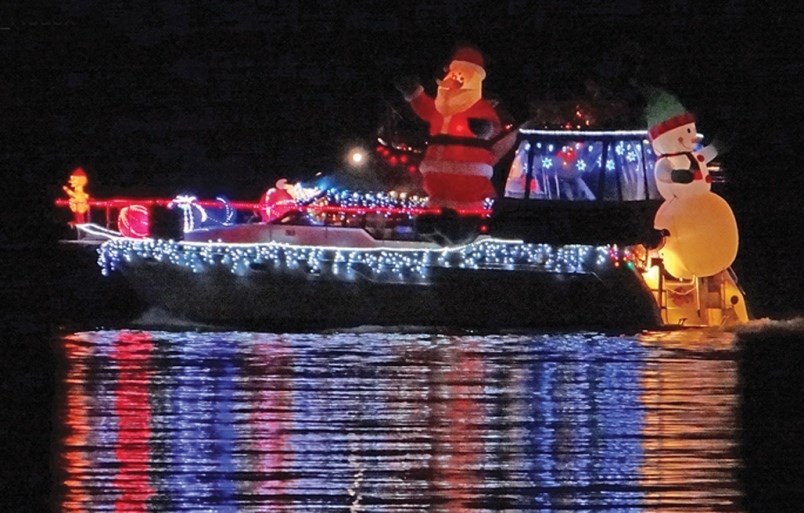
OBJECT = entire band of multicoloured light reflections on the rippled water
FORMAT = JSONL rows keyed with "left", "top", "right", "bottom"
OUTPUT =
{"left": 59, "top": 331, "right": 740, "bottom": 512}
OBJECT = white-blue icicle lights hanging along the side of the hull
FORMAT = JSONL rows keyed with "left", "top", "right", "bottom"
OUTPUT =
{"left": 98, "top": 234, "right": 620, "bottom": 284}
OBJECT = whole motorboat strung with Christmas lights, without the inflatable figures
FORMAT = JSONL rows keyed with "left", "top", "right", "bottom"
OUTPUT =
{"left": 57, "top": 128, "right": 748, "bottom": 330}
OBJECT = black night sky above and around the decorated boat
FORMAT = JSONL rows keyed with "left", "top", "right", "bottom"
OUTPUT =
{"left": 0, "top": 0, "right": 804, "bottom": 316}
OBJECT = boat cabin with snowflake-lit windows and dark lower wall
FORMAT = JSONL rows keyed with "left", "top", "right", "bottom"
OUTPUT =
{"left": 490, "top": 129, "right": 662, "bottom": 246}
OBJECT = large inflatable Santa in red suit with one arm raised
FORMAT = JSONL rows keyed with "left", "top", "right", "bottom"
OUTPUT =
{"left": 395, "top": 46, "right": 502, "bottom": 209}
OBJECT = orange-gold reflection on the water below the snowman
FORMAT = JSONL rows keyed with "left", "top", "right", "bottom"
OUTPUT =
{"left": 641, "top": 331, "right": 741, "bottom": 511}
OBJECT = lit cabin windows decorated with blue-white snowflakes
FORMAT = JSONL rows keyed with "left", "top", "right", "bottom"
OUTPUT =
{"left": 505, "top": 129, "right": 661, "bottom": 201}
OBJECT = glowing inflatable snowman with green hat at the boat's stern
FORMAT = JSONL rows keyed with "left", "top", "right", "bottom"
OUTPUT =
{"left": 648, "top": 93, "right": 738, "bottom": 279}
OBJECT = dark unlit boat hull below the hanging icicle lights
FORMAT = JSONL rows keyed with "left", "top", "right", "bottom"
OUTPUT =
{"left": 119, "top": 259, "right": 661, "bottom": 330}
